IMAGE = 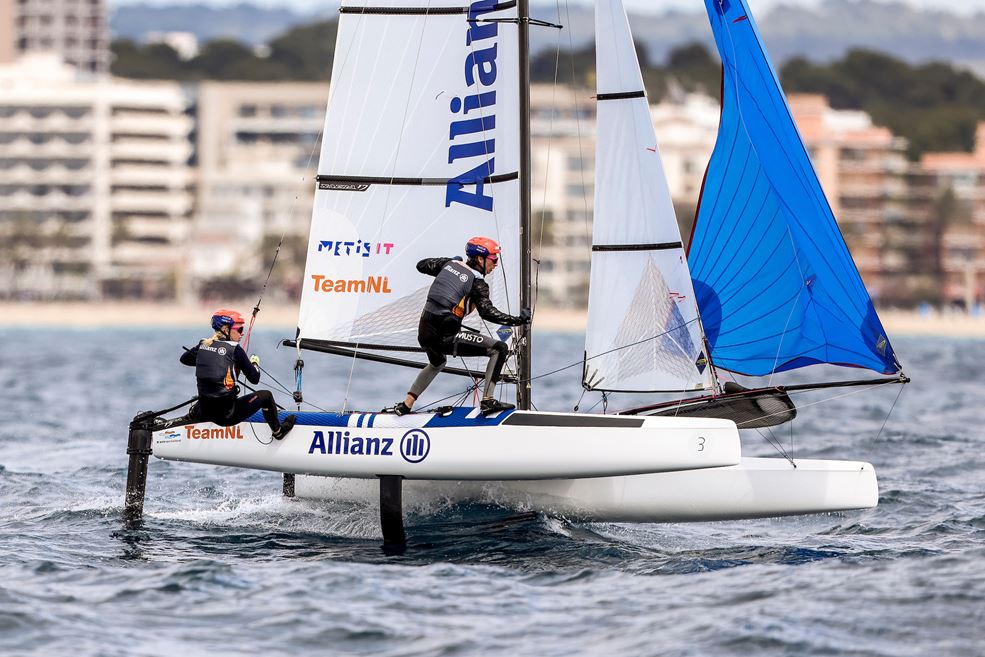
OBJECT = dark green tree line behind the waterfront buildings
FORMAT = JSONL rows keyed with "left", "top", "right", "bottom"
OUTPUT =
{"left": 112, "top": 21, "right": 985, "bottom": 158}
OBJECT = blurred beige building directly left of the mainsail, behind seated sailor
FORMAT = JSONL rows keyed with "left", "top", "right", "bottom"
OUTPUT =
{"left": 189, "top": 82, "right": 328, "bottom": 298}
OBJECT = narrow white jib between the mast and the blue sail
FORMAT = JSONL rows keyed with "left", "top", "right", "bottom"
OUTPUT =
{"left": 584, "top": 0, "right": 713, "bottom": 392}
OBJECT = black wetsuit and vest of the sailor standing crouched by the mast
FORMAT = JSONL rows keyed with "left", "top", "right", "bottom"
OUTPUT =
{"left": 415, "top": 258, "right": 526, "bottom": 386}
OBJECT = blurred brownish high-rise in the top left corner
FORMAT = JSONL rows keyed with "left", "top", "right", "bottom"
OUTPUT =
{"left": 0, "top": 0, "right": 110, "bottom": 75}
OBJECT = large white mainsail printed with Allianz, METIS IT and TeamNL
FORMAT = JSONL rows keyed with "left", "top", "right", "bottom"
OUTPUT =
{"left": 298, "top": 0, "right": 521, "bottom": 358}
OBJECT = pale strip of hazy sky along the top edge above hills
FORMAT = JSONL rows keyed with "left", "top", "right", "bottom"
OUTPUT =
{"left": 109, "top": 0, "right": 985, "bottom": 15}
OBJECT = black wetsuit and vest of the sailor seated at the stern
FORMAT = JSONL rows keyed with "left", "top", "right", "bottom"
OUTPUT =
{"left": 179, "top": 340, "right": 280, "bottom": 430}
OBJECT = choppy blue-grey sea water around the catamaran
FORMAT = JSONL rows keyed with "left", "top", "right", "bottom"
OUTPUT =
{"left": 0, "top": 329, "right": 985, "bottom": 657}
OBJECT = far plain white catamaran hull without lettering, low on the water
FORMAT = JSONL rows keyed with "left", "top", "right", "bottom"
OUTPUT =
{"left": 295, "top": 458, "right": 879, "bottom": 522}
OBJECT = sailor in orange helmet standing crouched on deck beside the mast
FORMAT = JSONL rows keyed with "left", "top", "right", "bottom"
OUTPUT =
{"left": 384, "top": 237, "right": 531, "bottom": 415}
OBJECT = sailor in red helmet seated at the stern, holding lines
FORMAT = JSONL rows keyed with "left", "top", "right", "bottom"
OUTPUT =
{"left": 180, "top": 309, "right": 295, "bottom": 440}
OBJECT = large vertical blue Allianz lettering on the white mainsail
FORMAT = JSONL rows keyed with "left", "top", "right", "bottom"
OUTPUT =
{"left": 445, "top": 0, "right": 499, "bottom": 212}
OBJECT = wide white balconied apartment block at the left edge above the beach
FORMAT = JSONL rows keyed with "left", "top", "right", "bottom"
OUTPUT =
{"left": 0, "top": 54, "right": 193, "bottom": 299}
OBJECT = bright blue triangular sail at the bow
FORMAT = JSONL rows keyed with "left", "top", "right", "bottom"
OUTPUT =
{"left": 688, "top": 0, "right": 899, "bottom": 375}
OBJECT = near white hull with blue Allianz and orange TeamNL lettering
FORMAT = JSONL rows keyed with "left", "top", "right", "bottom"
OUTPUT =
{"left": 153, "top": 408, "right": 741, "bottom": 480}
